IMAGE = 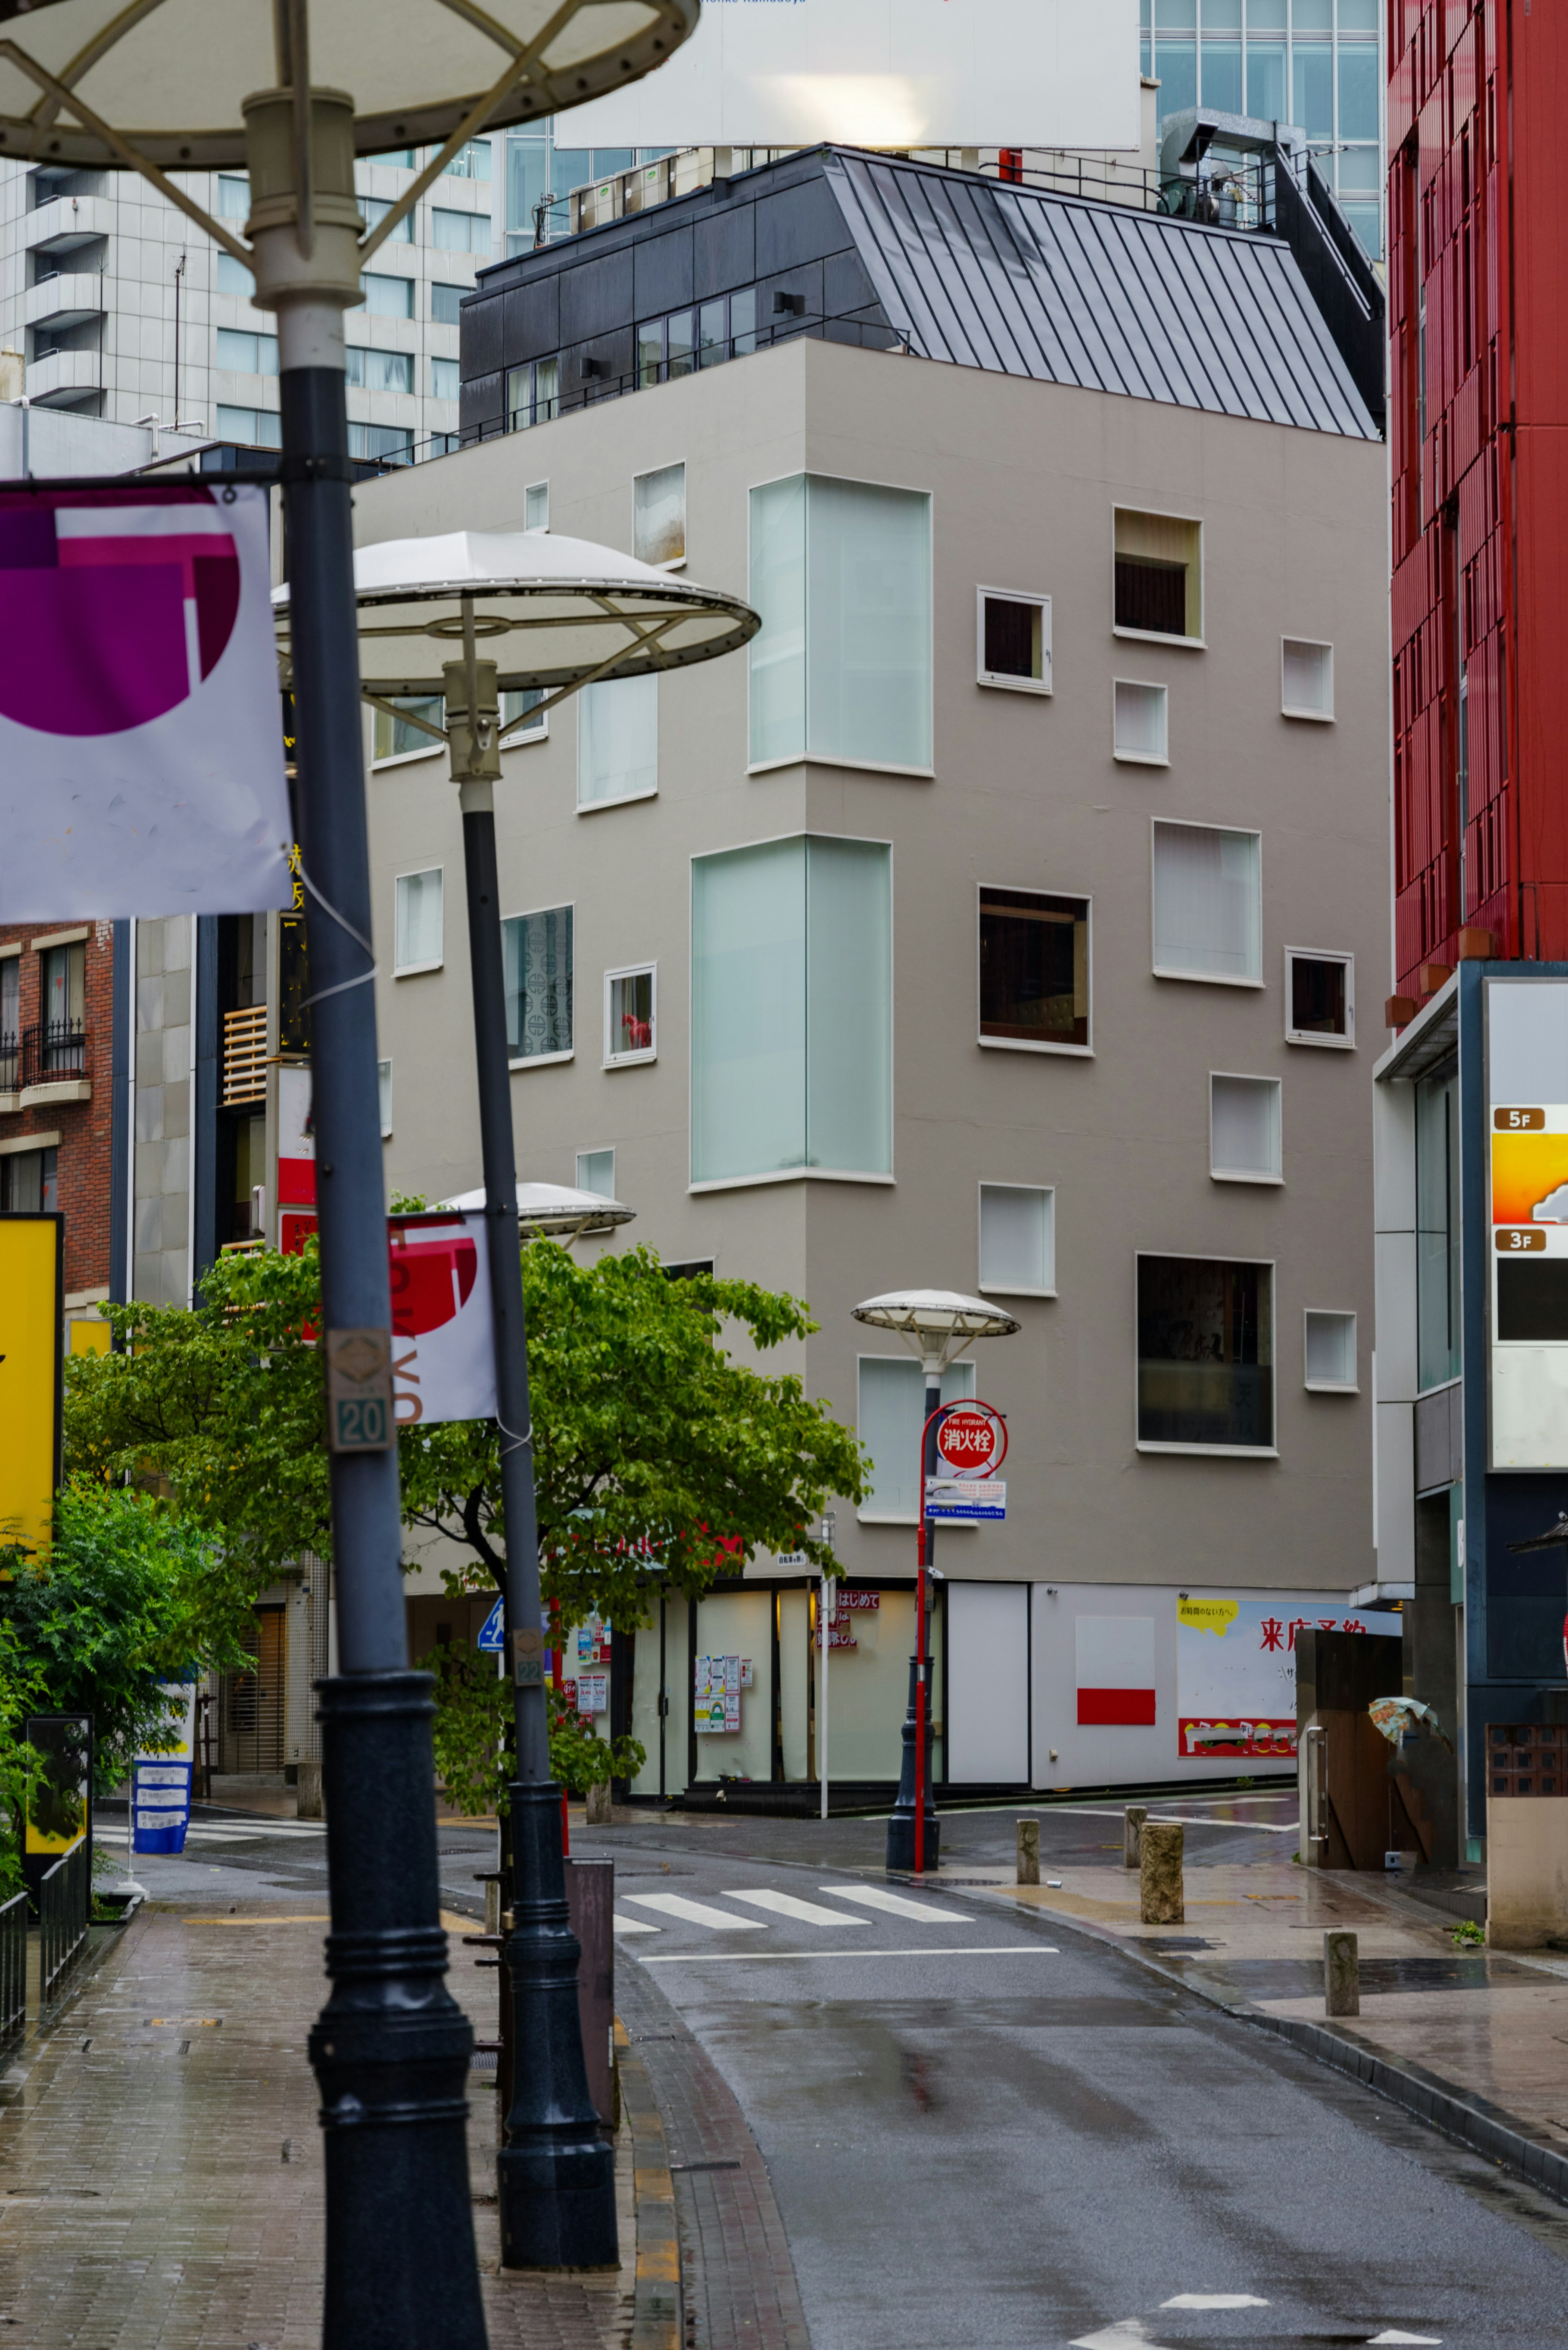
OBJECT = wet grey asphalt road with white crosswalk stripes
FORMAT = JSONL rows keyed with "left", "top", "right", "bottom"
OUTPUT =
{"left": 107, "top": 1802, "right": 1568, "bottom": 2350}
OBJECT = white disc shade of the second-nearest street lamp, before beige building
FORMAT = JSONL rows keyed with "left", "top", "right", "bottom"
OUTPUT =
{"left": 273, "top": 531, "right": 762, "bottom": 696}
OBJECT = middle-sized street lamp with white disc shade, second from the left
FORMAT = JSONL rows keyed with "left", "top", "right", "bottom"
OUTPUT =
{"left": 273, "top": 531, "right": 762, "bottom": 2268}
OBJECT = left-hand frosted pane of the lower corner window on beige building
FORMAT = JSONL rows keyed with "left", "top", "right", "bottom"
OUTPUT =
{"left": 691, "top": 839, "right": 806, "bottom": 1182}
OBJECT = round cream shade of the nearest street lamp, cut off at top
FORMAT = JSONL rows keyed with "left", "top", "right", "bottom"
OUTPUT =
{"left": 0, "top": 0, "right": 698, "bottom": 172}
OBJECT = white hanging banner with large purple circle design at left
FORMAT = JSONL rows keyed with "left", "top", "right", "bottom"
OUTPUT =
{"left": 0, "top": 482, "right": 292, "bottom": 921}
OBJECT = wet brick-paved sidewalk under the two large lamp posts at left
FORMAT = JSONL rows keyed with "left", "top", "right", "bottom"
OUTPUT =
{"left": 0, "top": 1899, "right": 648, "bottom": 2350}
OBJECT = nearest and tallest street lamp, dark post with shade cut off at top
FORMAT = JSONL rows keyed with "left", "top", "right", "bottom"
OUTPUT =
{"left": 0, "top": 0, "right": 698, "bottom": 2350}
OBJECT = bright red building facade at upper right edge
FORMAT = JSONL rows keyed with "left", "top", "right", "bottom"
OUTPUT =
{"left": 1387, "top": 0, "right": 1568, "bottom": 1001}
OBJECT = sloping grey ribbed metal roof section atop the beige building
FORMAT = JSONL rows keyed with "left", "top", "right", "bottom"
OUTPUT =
{"left": 823, "top": 148, "right": 1380, "bottom": 439}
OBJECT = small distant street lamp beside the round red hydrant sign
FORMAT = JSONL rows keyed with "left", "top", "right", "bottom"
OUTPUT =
{"left": 853, "top": 1290, "right": 1020, "bottom": 1875}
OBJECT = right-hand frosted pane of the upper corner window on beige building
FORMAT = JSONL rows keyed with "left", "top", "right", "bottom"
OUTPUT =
{"left": 806, "top": 477, "right": 931, "bottom": 769}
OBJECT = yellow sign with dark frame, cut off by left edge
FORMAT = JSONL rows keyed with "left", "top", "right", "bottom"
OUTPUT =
{"left": 0, "top": 1215, "right": 63, "bottom": 1551}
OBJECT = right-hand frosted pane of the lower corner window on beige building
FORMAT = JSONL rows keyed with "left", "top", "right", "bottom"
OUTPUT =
{"left": 806, "top": 839, "right": 893, "bottom": 1175}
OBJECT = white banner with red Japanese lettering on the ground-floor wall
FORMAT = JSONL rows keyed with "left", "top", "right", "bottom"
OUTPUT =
{"left": 1176, "top": 1591, "right": 1403, "bottom": 1760}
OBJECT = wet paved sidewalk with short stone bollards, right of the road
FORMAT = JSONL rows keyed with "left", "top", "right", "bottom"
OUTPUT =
{"left": 973, "top": 1842, "right": 1568, "bottom": 2200}
